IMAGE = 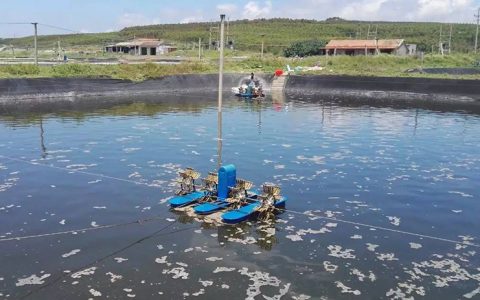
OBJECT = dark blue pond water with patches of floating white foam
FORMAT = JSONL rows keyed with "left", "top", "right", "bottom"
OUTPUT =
{"left": 0, "top": 94, "right": 480, "bottom": 299}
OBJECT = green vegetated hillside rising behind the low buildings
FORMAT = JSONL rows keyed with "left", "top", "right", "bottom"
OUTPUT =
{"left": 0, "top": 18, "right": 475, "bottom": 54}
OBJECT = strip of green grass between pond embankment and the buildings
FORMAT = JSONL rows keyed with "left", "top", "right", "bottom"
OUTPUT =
{"left": 0, "top": 51, "right": 480, "bottom": 81}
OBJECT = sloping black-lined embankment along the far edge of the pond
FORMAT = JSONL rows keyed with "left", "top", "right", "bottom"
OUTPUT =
{"left": 0, "top": 74, "right": 480, "bottom": 112}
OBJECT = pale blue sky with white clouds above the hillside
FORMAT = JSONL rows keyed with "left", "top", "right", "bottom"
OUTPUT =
{"left": 0, "top": 0, "right": 480, "bottom": 38}
